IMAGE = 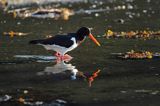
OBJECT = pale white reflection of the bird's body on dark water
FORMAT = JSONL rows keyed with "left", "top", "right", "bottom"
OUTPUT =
{"left": 37, "top": 61, "right": 83, "bottom": 80}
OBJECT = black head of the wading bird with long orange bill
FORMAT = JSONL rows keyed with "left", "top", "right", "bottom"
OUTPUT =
{"left": 76, "top": 27, "right": 100, "bottom": 46}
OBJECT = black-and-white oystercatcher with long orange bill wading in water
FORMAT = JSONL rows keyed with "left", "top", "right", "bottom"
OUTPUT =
{"left": 29, "top": 27, "right": 100, "bottom": 60}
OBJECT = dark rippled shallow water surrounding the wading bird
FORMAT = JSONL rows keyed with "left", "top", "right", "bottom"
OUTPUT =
{"left": 0, "top": 0, "right": 160, "bottom": 106}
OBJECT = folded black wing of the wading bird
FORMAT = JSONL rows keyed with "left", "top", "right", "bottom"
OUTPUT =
{"left": 41, "top": 35, "right": 74, "bottom": 48}
